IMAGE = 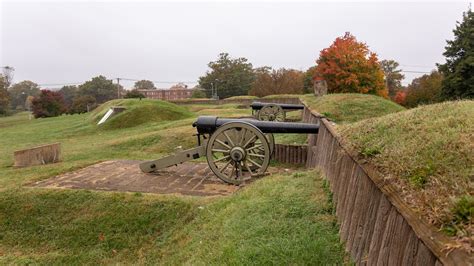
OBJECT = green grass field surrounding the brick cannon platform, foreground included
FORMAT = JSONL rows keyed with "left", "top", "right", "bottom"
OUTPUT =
{"left": 0, "top": 99, "right": 347, "bottom": 265}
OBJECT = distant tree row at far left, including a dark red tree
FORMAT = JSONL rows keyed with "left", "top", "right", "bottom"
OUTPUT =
{"left": 0, "top": 74, "right": 156, "bottom": 117}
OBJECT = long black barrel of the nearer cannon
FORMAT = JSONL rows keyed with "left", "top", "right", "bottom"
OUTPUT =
{"left": 193, "top": 116, "right": 319, "bottom": 134}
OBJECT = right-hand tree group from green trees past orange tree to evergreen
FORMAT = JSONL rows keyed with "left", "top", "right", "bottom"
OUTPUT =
{"left": 199, "top": 10, "right": 474, "bottom": 107}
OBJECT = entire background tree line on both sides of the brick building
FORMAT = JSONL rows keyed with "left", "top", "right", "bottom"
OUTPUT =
{"left": 0, "top": 9, "right": 474, "bottom": 117}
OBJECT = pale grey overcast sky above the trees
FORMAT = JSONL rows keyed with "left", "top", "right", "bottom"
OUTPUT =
{"left": 0, "top": 0, "right": 469, "bottom": 88}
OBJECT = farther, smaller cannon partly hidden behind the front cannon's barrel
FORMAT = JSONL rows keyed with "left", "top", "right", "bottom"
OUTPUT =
{"left": 250, "top": 102, "right": 304, "bottom": 122}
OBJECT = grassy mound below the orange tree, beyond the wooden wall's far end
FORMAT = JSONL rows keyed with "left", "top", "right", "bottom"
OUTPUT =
{"left": 300, "top": 93, "right": 405, "bottom": 124}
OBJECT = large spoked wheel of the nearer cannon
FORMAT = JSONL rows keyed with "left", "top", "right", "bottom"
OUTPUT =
{"left": 206, "top": 122, "right": 270, "bottom": 185}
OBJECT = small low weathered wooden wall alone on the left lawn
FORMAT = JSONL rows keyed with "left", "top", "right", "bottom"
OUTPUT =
{"left": 13, "top": 143, "right": 61, "bottom": 167}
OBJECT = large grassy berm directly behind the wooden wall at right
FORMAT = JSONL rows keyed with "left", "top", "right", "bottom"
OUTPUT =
{"left": 337, "top": 101, "right": 474, "bottom": 241}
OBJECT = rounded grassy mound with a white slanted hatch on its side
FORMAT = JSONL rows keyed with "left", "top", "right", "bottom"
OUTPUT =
{"left": 91, "top": 99, "right": 193, "bottom": 129}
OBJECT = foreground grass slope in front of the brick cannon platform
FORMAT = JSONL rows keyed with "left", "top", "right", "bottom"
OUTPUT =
{"left": 0, "top": 172, "right": 344, "bottom": 265}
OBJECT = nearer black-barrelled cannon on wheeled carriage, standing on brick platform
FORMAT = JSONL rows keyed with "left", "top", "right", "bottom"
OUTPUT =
{"left": 140, "top": 116, "right": 319, "bottom": 185}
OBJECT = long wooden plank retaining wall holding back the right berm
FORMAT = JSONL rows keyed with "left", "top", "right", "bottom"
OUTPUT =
{"left": 303, "top": 109, "right": 472, "bottom": 265}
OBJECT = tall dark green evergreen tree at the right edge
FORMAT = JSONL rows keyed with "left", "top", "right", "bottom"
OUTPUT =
{"left": 438, "top": 9, "right": 474, "bottom": 100}
